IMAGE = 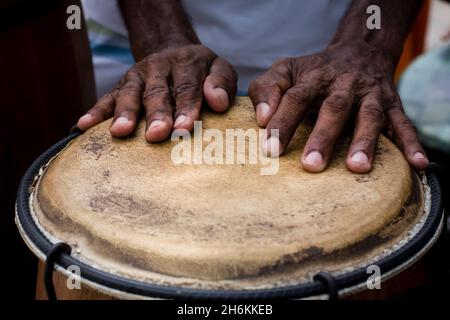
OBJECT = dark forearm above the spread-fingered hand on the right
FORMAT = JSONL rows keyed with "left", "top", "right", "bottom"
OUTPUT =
{"left": 329, "top": 0, "right": 423, "bottom": 64}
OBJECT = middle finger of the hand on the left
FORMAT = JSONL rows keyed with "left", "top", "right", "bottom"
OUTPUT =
{"left": 142, "top": 65, "right": 173, "bottom": 142}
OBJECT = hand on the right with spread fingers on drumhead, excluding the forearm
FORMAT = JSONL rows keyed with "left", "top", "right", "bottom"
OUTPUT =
{"left": 249, "top": 46, "right": 428, "bottom": 173}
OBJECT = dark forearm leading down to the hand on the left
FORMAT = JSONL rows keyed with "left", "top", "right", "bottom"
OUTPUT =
{"left": 119, "top": 0, "right": 200, "bottom": 61}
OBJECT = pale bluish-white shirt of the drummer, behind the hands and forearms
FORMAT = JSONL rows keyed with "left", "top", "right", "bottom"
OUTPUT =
{"left": 83, "top": 0, "right": 351, "bottom": 94}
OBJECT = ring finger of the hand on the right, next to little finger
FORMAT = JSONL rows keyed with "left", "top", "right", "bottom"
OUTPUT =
{"left": 346, "top": 93, "right": 385, "bottom": 173}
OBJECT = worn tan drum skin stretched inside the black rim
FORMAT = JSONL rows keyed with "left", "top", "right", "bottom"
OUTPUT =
{"left": 29, "top": 98, "right": 424, "bottom": 298}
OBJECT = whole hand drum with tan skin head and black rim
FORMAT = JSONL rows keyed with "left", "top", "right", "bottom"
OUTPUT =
{"left": 16, "top": 97, "right": 443, "bottom": 299}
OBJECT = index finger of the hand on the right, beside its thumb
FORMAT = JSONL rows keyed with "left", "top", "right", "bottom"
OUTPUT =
{"left": 261, "top": 86, "right": 313, "bottom": 157}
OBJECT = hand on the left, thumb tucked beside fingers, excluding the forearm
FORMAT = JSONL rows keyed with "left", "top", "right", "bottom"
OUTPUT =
{"left": 77, "top": 45, "right": 237, "bottom": 142}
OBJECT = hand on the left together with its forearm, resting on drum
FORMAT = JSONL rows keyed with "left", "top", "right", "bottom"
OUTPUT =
{"left": 78, "top": 0, "right": 237, "bottom": 142}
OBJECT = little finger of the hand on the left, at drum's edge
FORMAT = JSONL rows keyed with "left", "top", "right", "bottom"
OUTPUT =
{"left": 77, "top": 92, "right": 115, "bottom": 131}
